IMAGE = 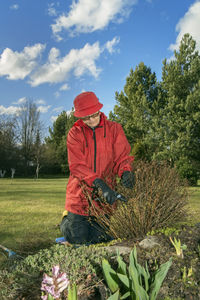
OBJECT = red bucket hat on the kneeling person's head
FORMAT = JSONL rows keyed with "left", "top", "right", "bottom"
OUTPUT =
{"left": 74, "top": 92, "right": 103, "bottom": 118}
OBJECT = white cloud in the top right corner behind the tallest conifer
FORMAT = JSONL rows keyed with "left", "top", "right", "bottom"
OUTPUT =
{"left": 169, "top": 1, "right": 200, "bottom": 51}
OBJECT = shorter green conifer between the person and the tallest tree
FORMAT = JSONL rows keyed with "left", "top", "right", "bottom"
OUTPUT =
{"left": 109, "top": 62, "right": 163, "bottom": 158}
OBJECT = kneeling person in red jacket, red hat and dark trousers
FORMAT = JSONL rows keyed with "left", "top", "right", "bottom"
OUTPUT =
{"left": 61, "top": 92, "right": 134, "bottom": 244}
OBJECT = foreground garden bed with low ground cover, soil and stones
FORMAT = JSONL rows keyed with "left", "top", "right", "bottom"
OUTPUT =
{"left": 0, "top": 224, "right": 200, "bottom": 300}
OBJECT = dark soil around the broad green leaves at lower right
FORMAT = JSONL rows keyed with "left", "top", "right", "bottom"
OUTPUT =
{"left": 79, "top": 223, "right": 200, "bottom": 300}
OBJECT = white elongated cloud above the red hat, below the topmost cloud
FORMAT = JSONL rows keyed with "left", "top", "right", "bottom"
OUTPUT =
{"left": 29, "top": 42, "right": 101, "bottom": 86}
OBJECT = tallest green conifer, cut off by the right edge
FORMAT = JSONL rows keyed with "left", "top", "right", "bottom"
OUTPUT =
{"left": 157, "top": 34, "right": 200, "bottom": 183}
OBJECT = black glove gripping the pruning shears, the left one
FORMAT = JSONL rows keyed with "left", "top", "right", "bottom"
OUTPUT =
{"left": 93, "top": 178, "right": 119, "bottom": 205}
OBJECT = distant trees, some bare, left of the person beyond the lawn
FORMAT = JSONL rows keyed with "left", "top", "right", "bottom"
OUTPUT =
{"left": 0, "top": 99, "right": 75, "bottom": 178}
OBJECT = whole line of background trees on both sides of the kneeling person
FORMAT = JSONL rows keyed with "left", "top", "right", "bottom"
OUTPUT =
{"left": 0, "top": 34, "right": 200, "bottom": 184}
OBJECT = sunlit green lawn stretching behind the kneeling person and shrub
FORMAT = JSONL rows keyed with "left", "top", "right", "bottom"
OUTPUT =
{"left": 0, "top": 178, "right": 200, "bottom": 260}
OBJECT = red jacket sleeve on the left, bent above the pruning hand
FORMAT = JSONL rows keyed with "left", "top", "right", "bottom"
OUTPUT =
{"left": 67, "top": 128, "right": 97, "bottom": 186}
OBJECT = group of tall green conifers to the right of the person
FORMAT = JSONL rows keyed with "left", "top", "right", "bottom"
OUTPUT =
{"left": 109, "top": 34, "right": 200, "bottom": 183}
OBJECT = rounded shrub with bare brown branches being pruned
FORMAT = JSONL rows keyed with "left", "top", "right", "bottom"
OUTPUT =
{"left": 83, "top": 161, "right": 188, "bottom": 238}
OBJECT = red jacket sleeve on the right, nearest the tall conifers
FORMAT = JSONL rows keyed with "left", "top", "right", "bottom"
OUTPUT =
{"left": 114, "top": 123, "right": 134, "bottom": 177}
